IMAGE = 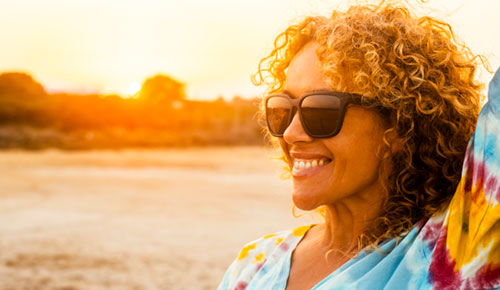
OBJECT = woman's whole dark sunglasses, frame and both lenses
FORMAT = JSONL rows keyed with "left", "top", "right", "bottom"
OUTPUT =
{"left": 265, "top": 91, "right": 362, "bottom": 138}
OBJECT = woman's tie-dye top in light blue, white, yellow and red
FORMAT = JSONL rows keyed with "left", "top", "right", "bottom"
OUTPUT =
{"left": 218, "top": 70, "right": 500, "bottom": 290}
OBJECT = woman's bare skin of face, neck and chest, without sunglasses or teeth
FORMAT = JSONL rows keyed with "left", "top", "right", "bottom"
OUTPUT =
{"left": 280, "top": 43, "right": 394, "bottom": 290}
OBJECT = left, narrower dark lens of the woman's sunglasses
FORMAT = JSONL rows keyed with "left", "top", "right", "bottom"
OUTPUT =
{"left": 266, "top": 96, "right": 293, "bottom": 135}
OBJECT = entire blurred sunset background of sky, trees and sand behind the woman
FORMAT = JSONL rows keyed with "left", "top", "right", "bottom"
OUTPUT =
{"left": 0, "top": 0, "right": 500, "bottom": 290}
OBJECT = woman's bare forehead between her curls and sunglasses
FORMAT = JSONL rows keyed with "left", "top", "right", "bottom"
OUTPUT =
{"left": 284, "top": 42, "right": 330, "bottom": 97}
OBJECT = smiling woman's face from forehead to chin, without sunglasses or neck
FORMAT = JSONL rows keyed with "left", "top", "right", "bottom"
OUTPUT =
{"left": 280, "top": 43, "right": 387, "bottom": 210}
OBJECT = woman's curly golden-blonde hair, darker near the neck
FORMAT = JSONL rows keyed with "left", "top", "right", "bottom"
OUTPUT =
{"left": 253, "top": 1, "right": 487, "bottom": 248}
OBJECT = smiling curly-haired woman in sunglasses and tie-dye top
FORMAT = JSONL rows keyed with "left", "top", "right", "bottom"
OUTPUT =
{"left": 219, "top": 3, "right": 500, "bottom": 290}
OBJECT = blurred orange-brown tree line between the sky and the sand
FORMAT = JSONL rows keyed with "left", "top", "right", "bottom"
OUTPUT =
{"left": 0, "top": 72, "right": 264, "bottom": 149}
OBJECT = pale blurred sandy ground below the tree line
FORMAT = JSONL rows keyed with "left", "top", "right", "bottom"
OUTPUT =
{"left": 0, "top": 147, "right": 311, "bottom": 290}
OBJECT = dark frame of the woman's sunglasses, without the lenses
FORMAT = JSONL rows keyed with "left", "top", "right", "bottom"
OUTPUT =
{"left": 264, "top": 91, "right": 362, "bottom": 138}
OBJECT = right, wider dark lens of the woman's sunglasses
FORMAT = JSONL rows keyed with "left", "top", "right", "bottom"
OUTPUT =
{"left": 301, "top": 95, "right": 341, "bottom": 137}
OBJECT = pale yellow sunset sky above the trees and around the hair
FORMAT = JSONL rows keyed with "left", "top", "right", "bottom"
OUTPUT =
{"left": 0, "top": 0, "right": 500, "bottom": 99}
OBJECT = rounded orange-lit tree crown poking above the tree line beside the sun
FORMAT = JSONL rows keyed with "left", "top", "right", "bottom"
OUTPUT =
{"left": 139, "top": 74, "right": 186, "bottom": 104}
